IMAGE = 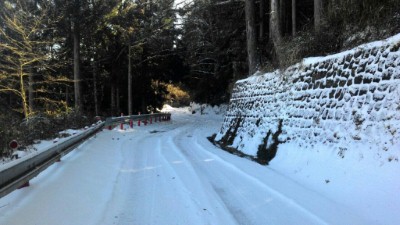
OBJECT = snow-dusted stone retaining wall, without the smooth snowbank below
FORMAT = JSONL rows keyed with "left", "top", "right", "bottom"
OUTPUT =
{"left": 215, "top": 34, "right": 400, "bottom": 162}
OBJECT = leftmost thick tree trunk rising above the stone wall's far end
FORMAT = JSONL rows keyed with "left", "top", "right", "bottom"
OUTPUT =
{"left": 245, "top": 0, "right": 258, "bottom": 75}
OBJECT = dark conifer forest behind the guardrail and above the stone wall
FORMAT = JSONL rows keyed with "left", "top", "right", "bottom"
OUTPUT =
{"left": 0, "top": 0, "right": 400, "bottom": 149}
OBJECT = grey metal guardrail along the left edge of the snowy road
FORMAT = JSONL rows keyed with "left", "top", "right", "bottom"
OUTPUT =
{"left": 0, "top": 113, "right": 171, "bottom": 198}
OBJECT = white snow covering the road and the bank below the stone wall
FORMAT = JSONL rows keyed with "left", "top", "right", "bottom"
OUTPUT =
{"left": 0, "top": 107, "right": 400, "bottom": 225}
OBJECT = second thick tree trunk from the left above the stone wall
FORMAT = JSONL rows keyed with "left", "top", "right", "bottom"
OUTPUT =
{"left": 269, "top": 0, "right": 281, "bottom": 64}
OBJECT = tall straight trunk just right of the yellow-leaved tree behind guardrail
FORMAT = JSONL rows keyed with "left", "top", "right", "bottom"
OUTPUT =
{"left": 72, "top": 0, "right": 82, "bottom": 111}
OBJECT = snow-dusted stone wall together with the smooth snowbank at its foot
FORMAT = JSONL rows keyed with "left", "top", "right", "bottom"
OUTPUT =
{"left": 215, "top": 34, "right": 400, "bottom": 224}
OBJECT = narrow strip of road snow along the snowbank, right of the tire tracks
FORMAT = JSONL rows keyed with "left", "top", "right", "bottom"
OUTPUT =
{"left": 186, "top": 120, "right": 368, "bottom": 224}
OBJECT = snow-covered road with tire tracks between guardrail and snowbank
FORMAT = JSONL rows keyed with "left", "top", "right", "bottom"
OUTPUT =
{"left": 0, "top": 108, "right": 394, "bottom": 225}
